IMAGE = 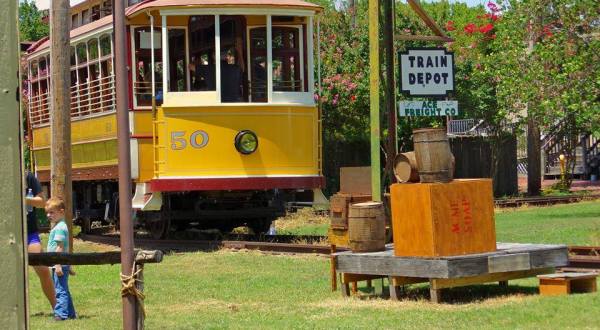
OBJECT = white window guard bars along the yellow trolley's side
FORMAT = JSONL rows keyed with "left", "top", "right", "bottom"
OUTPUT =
{"left": 29, "top": 76, "right": 115, "bottom": 127}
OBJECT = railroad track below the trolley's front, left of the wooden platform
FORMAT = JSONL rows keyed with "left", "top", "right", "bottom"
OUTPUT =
{"left": 78, "top": 234, "right": 342, "bottom": 255}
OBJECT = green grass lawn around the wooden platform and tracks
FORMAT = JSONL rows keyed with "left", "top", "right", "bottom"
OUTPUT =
{"left": 29, "top": 202, "right": 600, "bottom": 329}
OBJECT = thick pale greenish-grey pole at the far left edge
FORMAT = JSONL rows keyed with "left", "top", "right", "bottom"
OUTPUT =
{"left": 0, "top": 0, "right": 28, "bottom": 329}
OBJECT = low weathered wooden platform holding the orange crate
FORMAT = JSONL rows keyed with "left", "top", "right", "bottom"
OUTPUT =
{"left": 334, "top": 243, "right": 568, "bottom": 302}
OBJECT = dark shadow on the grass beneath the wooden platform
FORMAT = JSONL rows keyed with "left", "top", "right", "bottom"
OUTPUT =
{"left": 358, "top": 284, "right": 538, "bottom": 305}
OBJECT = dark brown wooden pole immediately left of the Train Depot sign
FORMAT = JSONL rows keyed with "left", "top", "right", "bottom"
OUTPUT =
{"left": 383, "top": 0, "right": 398, "bottom": 183}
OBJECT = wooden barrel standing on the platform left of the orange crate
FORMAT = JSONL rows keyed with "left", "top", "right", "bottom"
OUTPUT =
{"left": 348, "top": 202, "right": 385, "bottom": 252}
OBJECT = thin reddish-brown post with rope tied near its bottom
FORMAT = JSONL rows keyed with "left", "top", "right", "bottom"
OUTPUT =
{"left": 113, "top": 0, "right": 135, "bottom": 330}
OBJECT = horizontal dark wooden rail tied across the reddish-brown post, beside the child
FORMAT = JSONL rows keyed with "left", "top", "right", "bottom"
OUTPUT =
{"left": 28, "top": 250, "right": 163, "bottom": 266}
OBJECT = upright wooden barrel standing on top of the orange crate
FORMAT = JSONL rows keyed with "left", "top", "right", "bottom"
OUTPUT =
{"left": 413, "top": 128, "right": 453, "bottom": 182}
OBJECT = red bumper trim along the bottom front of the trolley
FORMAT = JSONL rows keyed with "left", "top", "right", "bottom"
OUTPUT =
{"left": 150, "top": 176, "right": 325, "bottom": 191}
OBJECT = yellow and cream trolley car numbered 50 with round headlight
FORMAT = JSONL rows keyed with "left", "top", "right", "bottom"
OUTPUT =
{"left": 27, "top": 0, "right": 324, "bottom": 238}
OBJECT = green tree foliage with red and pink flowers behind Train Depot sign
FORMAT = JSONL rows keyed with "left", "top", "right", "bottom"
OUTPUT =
{"left": 319, "top": 0, "right": 600, "bottom": 190}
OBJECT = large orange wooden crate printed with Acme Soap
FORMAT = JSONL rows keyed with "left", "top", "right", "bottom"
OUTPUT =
{"left": 391, "top": 179, "right": 496, "bottom": 257}
